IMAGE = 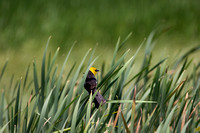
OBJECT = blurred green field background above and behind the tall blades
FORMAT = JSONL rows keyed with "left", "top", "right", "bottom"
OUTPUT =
{"left": 0, "top": 0, "right": 200, "bottom": 77}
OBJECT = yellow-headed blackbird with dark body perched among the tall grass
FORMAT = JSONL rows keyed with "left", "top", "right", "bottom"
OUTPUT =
{"left": 84, "top": 67, "right": 106, "bottom": 108}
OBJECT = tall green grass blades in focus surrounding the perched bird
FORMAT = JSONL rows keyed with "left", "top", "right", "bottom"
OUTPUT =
{"left": 0, "top": 33, "right": 200, "bottom": 133}
